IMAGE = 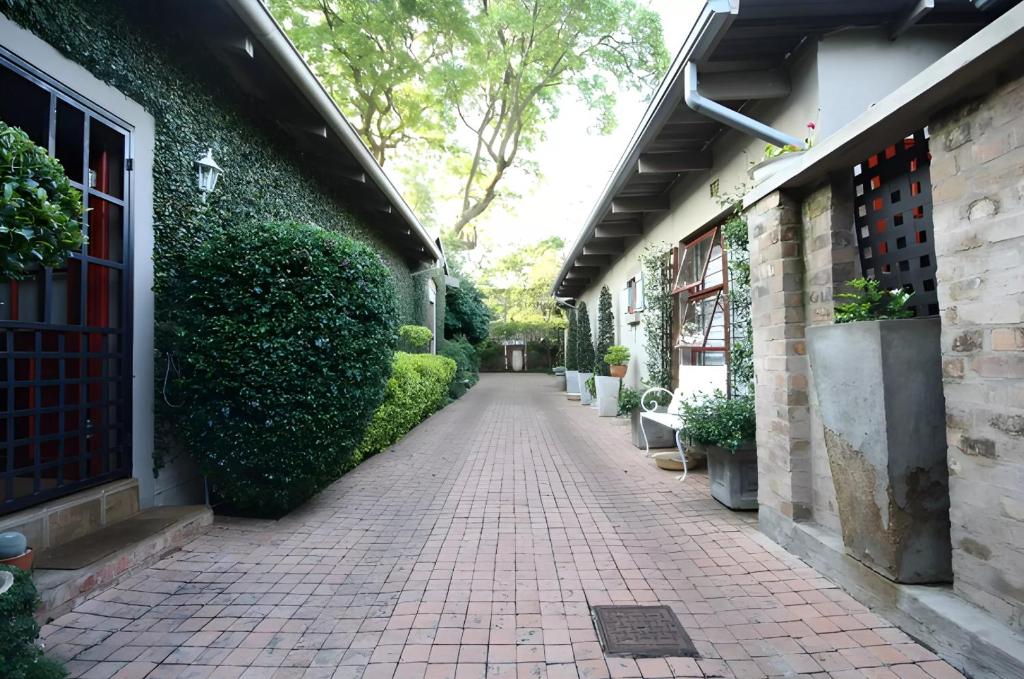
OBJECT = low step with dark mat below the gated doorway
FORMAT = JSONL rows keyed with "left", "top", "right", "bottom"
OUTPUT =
{"left": 33, "top": 505, "right": 213, "bottom": 620}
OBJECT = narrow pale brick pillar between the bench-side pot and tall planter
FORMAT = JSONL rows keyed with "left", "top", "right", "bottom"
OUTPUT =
{"left": 746, "top": 192, "right": 811, "bottom": 539}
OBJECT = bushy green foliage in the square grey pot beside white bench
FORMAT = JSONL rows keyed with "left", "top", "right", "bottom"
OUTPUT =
{"left": 680, "top": 391, "right": 757, "bottom": 452}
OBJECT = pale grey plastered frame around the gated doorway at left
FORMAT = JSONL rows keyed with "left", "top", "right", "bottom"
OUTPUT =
{"left": 0, "top": 14, "right": 198, "bottom": 507}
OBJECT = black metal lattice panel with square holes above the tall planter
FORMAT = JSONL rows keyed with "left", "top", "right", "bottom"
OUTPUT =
{"left": 853, "top": 130, "right": 939, "bottom": 316}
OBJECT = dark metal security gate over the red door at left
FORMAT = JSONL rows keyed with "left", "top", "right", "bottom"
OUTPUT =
{"left": 0, "top": 49, "right": 131, "bottom": 514}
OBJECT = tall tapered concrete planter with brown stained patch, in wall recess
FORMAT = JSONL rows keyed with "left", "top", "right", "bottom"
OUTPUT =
{"left": 807, "top": 319, "right": 952, "bottom": 584}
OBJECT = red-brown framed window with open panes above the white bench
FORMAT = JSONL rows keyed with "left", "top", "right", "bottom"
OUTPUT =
{"left": 673, "top": 227, "right": 729, "bottom": 366}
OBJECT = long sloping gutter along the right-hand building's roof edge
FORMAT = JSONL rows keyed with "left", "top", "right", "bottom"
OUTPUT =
{"left": 551, "top": 0, "right": 738, "bottom": 296}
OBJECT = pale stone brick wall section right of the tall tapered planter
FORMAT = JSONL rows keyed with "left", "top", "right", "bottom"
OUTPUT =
{"left": 931, "top": 77, "right": 1024, "bottom": 629}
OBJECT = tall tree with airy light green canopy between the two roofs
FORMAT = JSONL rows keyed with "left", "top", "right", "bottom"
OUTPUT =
{"left": 271, "top": 0, "right": 668, "bottom": 248}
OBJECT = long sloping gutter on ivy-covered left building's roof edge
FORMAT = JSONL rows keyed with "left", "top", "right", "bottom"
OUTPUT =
{"left": 224, "top": 0, "right": 443, "bottom": 261}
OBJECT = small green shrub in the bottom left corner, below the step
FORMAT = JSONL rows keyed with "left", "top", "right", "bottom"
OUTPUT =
{"left": 0, "top": 565, "right": 66, "bottom": 679}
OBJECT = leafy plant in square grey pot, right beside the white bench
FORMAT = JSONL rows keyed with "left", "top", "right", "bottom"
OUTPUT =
{"left": 680, "top": 391, "right": 758, "bottom": 509}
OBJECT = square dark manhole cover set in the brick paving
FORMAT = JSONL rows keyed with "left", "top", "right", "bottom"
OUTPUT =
{"left": 592, "top": 606, "right": 697, "bottom": 657}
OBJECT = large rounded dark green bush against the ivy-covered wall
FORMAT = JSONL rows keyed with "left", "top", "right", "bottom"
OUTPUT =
{"left": 167, "top": 223, "right": 397, "bottom": 516}
